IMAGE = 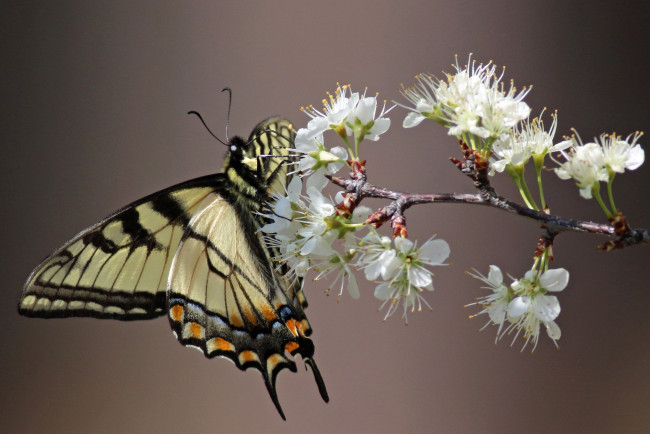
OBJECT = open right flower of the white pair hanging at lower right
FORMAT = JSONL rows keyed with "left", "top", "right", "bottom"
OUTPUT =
{"left": 504, "top": 268, "right": 569, "bottom": 351}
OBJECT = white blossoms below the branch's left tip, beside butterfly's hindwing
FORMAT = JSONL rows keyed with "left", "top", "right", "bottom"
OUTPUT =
{"left": 261, "top": 177, "right": 450, "bottom": 321}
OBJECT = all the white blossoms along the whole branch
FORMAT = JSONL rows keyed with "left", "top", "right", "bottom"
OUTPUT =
{"left": 261, "top": 56, "right": 645, "bottom": 350}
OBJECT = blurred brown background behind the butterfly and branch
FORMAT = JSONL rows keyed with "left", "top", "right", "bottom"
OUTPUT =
{"left": 0, "top": 0, "right": 650, "bottom": 433}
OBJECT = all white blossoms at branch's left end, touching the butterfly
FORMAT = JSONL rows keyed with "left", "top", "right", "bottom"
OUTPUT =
{"left": 261, "top": 86, "right": 449, "bottom": 321}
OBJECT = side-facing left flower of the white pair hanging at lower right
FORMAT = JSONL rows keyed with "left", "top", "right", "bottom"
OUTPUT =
{"left": 466, "top": 265, "right": 511, "bottom": 343}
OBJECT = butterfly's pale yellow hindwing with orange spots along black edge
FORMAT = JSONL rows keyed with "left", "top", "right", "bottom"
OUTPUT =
{"left": 168, "top": 194, "right": 297, "bottom": 418}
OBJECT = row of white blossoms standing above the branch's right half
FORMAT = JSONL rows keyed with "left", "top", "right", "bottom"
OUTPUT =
{"left": 402, "top": 56, "right": 644, "bottom": 217}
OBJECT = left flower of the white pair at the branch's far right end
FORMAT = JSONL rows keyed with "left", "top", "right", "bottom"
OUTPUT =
{"left": 555, "top": 139, "right": 609, "bottom": 199}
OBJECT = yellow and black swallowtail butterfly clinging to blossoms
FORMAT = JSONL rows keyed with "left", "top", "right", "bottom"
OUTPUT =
{"left": 18, "top": 117, "right": 329, "bottom": 419}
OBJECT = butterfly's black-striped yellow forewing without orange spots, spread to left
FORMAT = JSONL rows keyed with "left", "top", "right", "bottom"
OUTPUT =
{"left": 18, "top": 175, "right": 226, "bottom": 320}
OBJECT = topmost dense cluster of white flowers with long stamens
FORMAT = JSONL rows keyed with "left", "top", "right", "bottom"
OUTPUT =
{"left": 402, "top": 56, "right": 530, "bottom": 139}
